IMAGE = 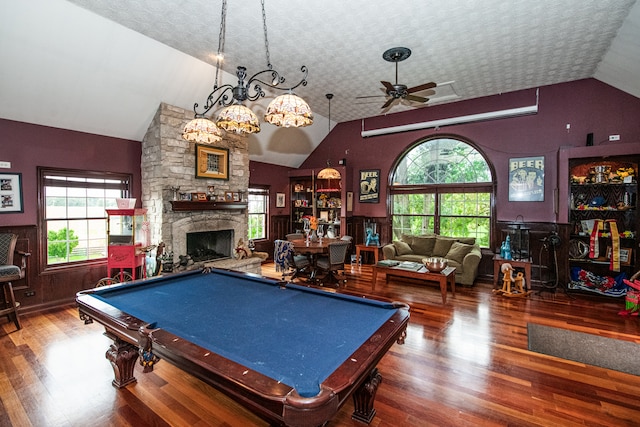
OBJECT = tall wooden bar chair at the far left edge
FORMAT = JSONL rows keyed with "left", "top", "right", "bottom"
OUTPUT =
{"left": 0, "top": 233, "right": 31, "bottom": 329}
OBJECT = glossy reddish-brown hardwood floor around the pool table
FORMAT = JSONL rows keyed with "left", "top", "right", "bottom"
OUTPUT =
{"left": 0, "top": 264, "right": 640, "bottom": 427}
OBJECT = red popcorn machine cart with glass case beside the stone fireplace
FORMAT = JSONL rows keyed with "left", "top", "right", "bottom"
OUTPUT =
{"left": 107, "top": 209, "right": 150, "bottom": 281}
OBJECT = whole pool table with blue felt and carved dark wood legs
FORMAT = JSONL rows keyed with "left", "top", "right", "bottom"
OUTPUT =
{"left": 76, "top": 269, "right": 409, "bottom": 426}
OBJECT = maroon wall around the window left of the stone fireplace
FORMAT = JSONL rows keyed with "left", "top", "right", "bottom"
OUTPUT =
{"left": 0, "top": 119, "right": 141, "bottom": 226}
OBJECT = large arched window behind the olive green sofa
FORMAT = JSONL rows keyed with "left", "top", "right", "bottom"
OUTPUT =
{"left": 389, "top": 136, "right": 494, "bottom": 247}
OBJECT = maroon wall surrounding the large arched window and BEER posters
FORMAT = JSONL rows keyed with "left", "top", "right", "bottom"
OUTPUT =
{"left": 301, "top": 79, "right": 640, "bottom": 222}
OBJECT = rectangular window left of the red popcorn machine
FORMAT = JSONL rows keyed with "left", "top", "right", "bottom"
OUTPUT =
{"left": 38, "top": 168, "right": 131, "bottom": 269}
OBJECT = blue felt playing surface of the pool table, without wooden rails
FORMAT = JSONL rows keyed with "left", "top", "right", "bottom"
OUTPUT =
{"left": 87, "top": 271, "right": 398, "bottom": 397}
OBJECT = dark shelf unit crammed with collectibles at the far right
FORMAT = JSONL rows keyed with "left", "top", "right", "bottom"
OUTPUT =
{"left": 569, "top": 156, "right": 638, "bottom": 284}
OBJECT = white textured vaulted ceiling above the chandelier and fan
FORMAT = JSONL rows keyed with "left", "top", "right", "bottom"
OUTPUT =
{"left": 0, "top": 0, "right": 640, "bottom": 166}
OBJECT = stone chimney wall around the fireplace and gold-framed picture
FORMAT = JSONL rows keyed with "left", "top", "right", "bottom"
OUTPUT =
{"left": 141, "top": 103, "right": 249, "bottom": 270}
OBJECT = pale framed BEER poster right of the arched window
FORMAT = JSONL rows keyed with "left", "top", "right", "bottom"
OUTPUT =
{"left": 509, "top": 156, "right": 544, "bottom": 202}
